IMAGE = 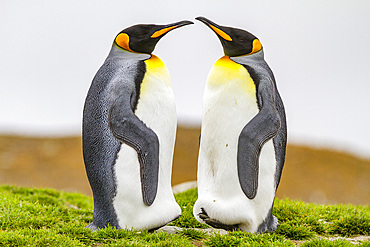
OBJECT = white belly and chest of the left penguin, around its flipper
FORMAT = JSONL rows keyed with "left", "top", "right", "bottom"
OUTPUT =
{"left": 113, "top": 58, "right": 181, "bottom": 229}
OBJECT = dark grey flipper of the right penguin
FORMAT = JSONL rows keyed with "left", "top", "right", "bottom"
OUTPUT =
{"left": 237, "top": 79, "right": 281, "bottom": 199}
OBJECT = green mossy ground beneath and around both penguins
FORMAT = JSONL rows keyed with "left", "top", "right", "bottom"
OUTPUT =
{"left": 0, "top": 185, "right": 370, "bottom": 246}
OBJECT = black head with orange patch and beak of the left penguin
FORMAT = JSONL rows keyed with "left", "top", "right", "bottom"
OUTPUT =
{"left": 114, "top": 21, "right": 193, "bottom": 54}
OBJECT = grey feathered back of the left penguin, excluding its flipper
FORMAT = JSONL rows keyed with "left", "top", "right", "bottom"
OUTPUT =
{"left": 82, "top": 48, "right": 145, "bottom": 230}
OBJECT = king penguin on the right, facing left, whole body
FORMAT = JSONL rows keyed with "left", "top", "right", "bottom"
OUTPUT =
{"left": 193, "top": 17, "right": 287, "bottom": 232}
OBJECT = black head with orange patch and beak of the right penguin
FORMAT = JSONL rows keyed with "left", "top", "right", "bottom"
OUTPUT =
{"left": 195, "top": 17, "right": 262, "bottom": 57}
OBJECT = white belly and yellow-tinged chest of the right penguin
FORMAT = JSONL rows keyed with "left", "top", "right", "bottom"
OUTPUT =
{"left": 194, "top": 56, "right": 276, "bottom": 232}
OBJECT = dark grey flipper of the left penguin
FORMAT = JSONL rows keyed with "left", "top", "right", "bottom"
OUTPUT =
{"left": 108, "top": 97, "right": 159, "bottom": 206}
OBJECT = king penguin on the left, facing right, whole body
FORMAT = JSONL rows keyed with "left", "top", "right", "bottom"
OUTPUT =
{"left": 82, "top": 21, "right": 193, "bottom": 230}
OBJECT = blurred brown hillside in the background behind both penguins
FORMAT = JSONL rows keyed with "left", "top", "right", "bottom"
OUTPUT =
{"left": 0, "top": 127, "right": 370, "bottom": 205}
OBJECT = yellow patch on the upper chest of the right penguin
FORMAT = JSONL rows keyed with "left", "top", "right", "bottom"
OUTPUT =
{"left": 207, "top": 56, "right": 256, "bottom": 95}
